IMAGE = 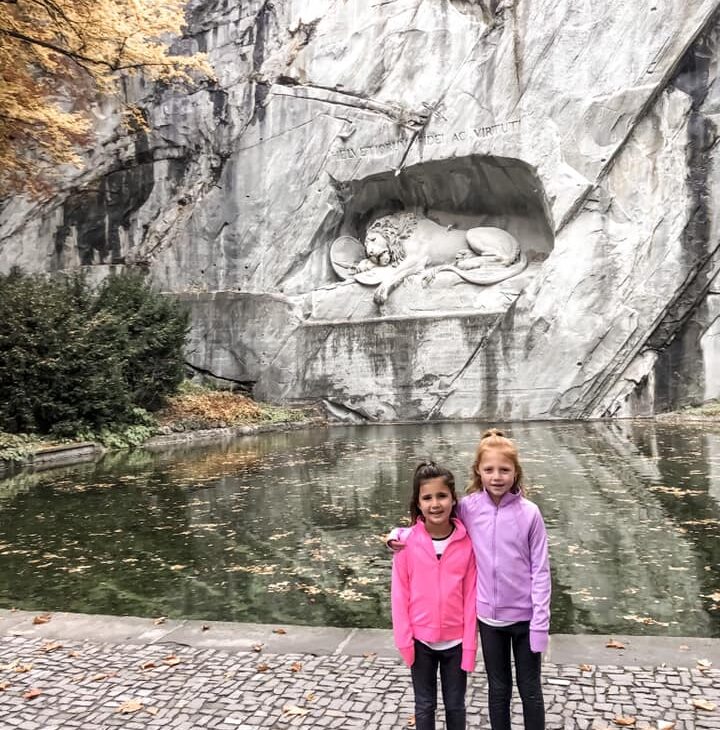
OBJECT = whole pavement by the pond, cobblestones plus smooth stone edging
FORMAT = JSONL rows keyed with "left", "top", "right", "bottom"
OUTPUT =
{"left": 0, "top": 611, "right": 720, "bottom": 730}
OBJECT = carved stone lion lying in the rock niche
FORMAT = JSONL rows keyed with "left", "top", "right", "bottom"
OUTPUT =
{"left": 330, "top": 212, "right": 527, "bottom": 305}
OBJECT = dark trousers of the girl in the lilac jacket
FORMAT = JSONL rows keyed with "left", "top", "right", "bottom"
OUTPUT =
{"left": 480, "top": 621, "right": 545, "bottom": 730}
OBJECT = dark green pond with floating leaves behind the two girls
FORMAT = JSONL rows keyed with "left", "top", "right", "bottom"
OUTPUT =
{"left": 0, "top": 422, "right": 720, "bottom": 637}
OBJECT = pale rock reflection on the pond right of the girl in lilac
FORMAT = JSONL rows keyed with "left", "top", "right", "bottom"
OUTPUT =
{"left": 513, "top": 426, "right": 712, "bottom": 635}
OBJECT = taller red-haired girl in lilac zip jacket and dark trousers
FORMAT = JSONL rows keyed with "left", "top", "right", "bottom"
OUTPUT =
{"left": 458, "top": 429, "right": 550, "bottom": 730}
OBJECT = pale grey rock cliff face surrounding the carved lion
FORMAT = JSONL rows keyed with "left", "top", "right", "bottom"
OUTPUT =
{"left": 0, "top": 0, "right": 720, "bottom": 420}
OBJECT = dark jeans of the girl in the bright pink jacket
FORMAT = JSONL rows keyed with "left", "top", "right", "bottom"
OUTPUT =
{"left": 410, "top": 639, "right": 467, "bottom": 730}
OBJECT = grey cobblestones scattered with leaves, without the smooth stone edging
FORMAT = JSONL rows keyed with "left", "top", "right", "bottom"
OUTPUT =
{"left": 0, "top": 636, "right": 720, "bottom": 730}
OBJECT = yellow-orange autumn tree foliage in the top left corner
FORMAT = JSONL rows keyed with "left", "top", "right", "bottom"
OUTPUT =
{"left": 0, "top": 0, "right": 209, "bottom": 198}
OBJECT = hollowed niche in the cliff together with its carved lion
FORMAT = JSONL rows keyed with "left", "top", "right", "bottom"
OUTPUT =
{"left": 318, "top": 155, "right": 553, "bottom": 318}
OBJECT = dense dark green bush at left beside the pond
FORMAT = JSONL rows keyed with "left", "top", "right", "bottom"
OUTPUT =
{"left": 0, "top": 270, "right": 188, "bottom": 436}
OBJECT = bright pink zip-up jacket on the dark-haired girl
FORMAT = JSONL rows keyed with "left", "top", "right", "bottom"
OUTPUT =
{"left": 391, "top": 518, "right": 477, "bottom": 672}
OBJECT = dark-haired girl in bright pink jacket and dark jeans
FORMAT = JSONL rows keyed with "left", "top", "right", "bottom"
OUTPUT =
{"left": 391, "top": 462, "right": 477, "bottom": 730}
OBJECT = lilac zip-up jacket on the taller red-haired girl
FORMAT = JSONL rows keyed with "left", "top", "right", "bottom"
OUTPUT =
{"left": 458, "top": 491, "right": 551, "bottom": 651}
